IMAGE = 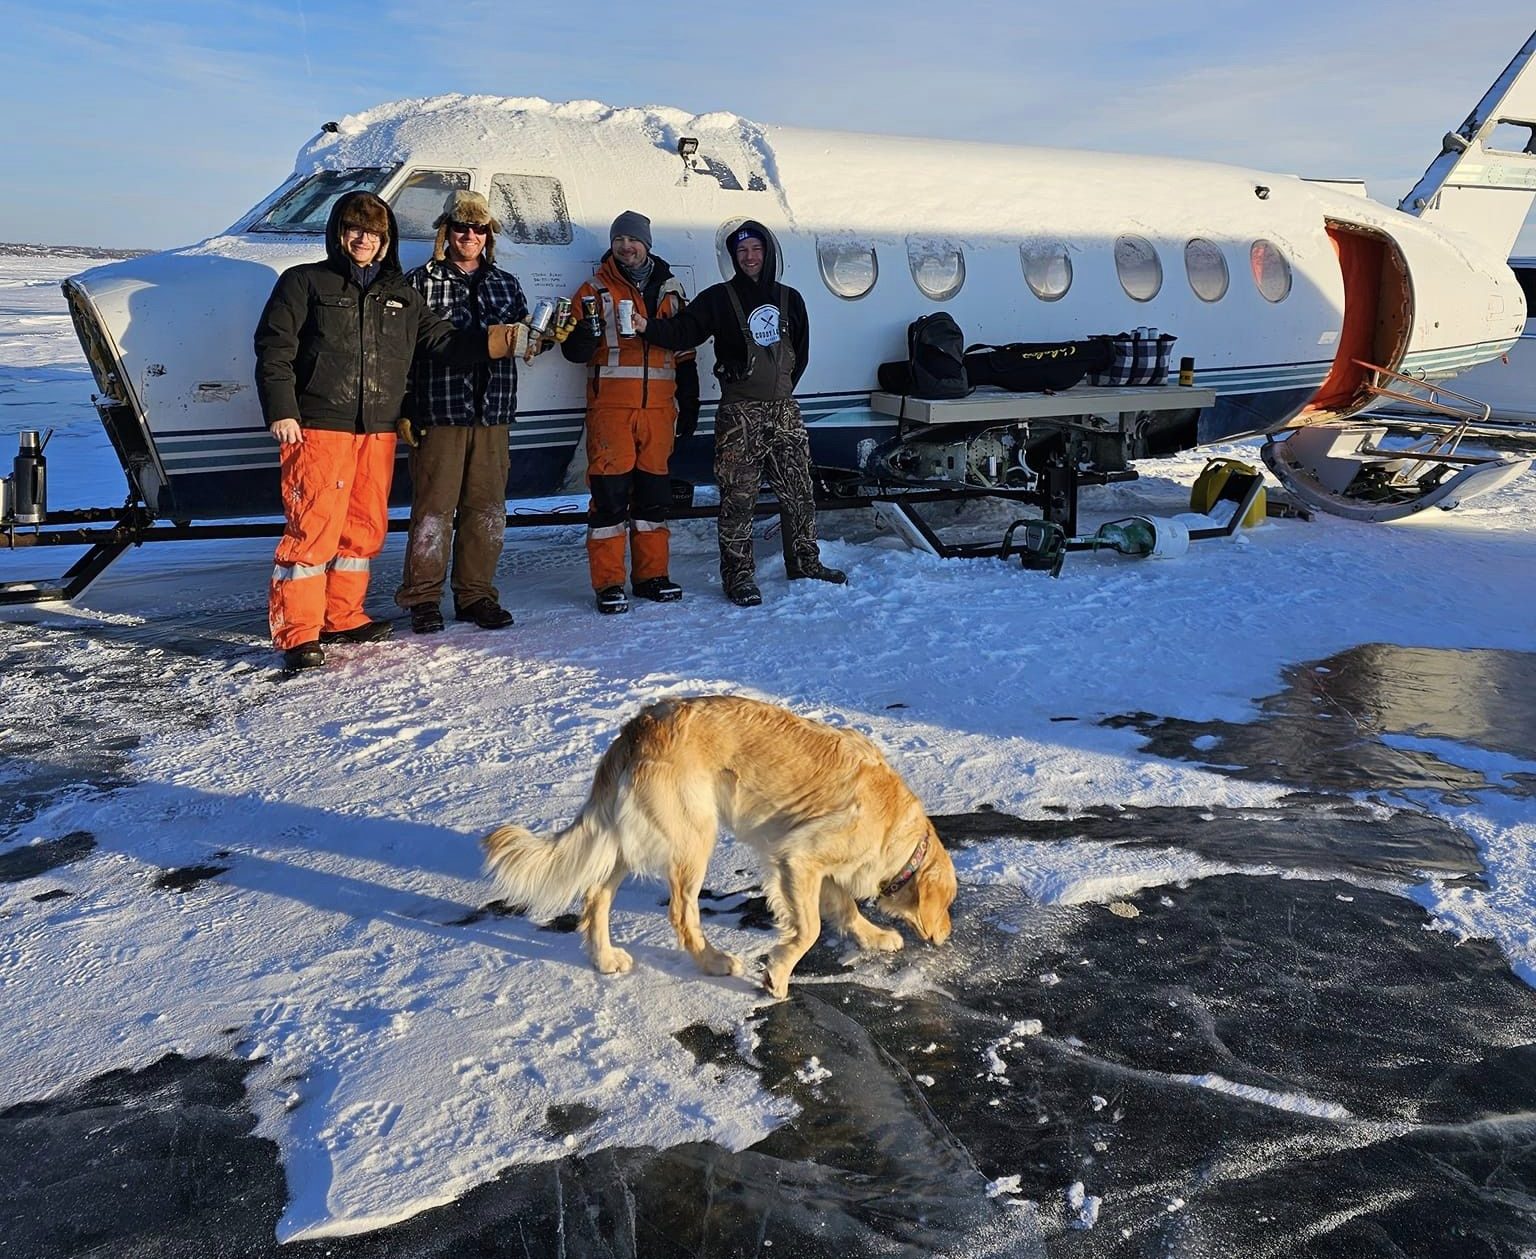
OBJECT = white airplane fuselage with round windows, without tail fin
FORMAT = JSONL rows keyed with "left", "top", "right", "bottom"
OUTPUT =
{"left": 66, "top": 97, "right": 1525, "bottom": 517}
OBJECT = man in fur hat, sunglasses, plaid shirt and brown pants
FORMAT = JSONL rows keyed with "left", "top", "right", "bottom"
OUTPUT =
{"left": 395, "top": 190, "right": 528, "bottom": 634}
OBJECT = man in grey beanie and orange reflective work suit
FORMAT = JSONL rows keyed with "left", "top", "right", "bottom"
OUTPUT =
{"left": 561, "top": 210, "right": 699, "bottom": 613}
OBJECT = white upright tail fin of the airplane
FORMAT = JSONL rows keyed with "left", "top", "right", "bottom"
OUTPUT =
{"left": 1398, "top": 34, "right": 1536, "bottom": 258}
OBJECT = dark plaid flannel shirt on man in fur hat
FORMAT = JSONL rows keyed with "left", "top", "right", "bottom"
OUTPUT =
{"left": 406, "top": 259, "right": 528, "bottom": 428}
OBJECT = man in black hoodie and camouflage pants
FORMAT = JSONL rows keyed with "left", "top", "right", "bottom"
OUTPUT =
{"left": 639, "top": 220, "right": 848, "bottom": 608}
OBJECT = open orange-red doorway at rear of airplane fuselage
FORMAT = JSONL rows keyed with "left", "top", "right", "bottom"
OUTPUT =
{"left": 1295, "top": 221, "right": 1413, "bottom": 424}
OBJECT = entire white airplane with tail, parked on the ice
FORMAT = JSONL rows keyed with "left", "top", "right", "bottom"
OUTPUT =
{"left": 29, "top": 34, "right": 1536, "bottom": 586}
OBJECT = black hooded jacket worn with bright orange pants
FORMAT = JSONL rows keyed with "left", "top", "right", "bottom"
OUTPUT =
{"left": 255, "top": 193, "right": 490, "bottom": 433}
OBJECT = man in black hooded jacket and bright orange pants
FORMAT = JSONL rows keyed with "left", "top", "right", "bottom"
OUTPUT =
{"left": 255, "top": 192, "right": 513, "bottom": 669}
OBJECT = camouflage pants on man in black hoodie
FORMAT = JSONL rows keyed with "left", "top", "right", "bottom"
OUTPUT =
{"left": 714, "top": 398, "right": 820, "bottom": 590}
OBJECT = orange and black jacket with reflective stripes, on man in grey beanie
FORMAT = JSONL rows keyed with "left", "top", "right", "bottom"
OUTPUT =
{"left": 561, "top": 249, "right": 699, "bottom": 415}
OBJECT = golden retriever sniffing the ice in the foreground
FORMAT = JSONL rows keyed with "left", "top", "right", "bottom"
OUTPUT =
{"left": 482, "top": 696, "right": 955, "bottom": 996}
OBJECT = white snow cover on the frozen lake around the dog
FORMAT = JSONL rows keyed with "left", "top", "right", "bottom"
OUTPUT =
{"left": 0, "top": 253, "right": 1536, "bottom": 1239}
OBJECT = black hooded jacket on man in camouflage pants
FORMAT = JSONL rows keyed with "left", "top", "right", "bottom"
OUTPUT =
{"left": 642, "top": 218, "right": 811, "bottom": 402}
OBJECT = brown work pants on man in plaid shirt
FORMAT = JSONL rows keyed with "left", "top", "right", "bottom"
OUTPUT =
{"left": 395, "top": 424, "right": 510, "bottom": 610}
